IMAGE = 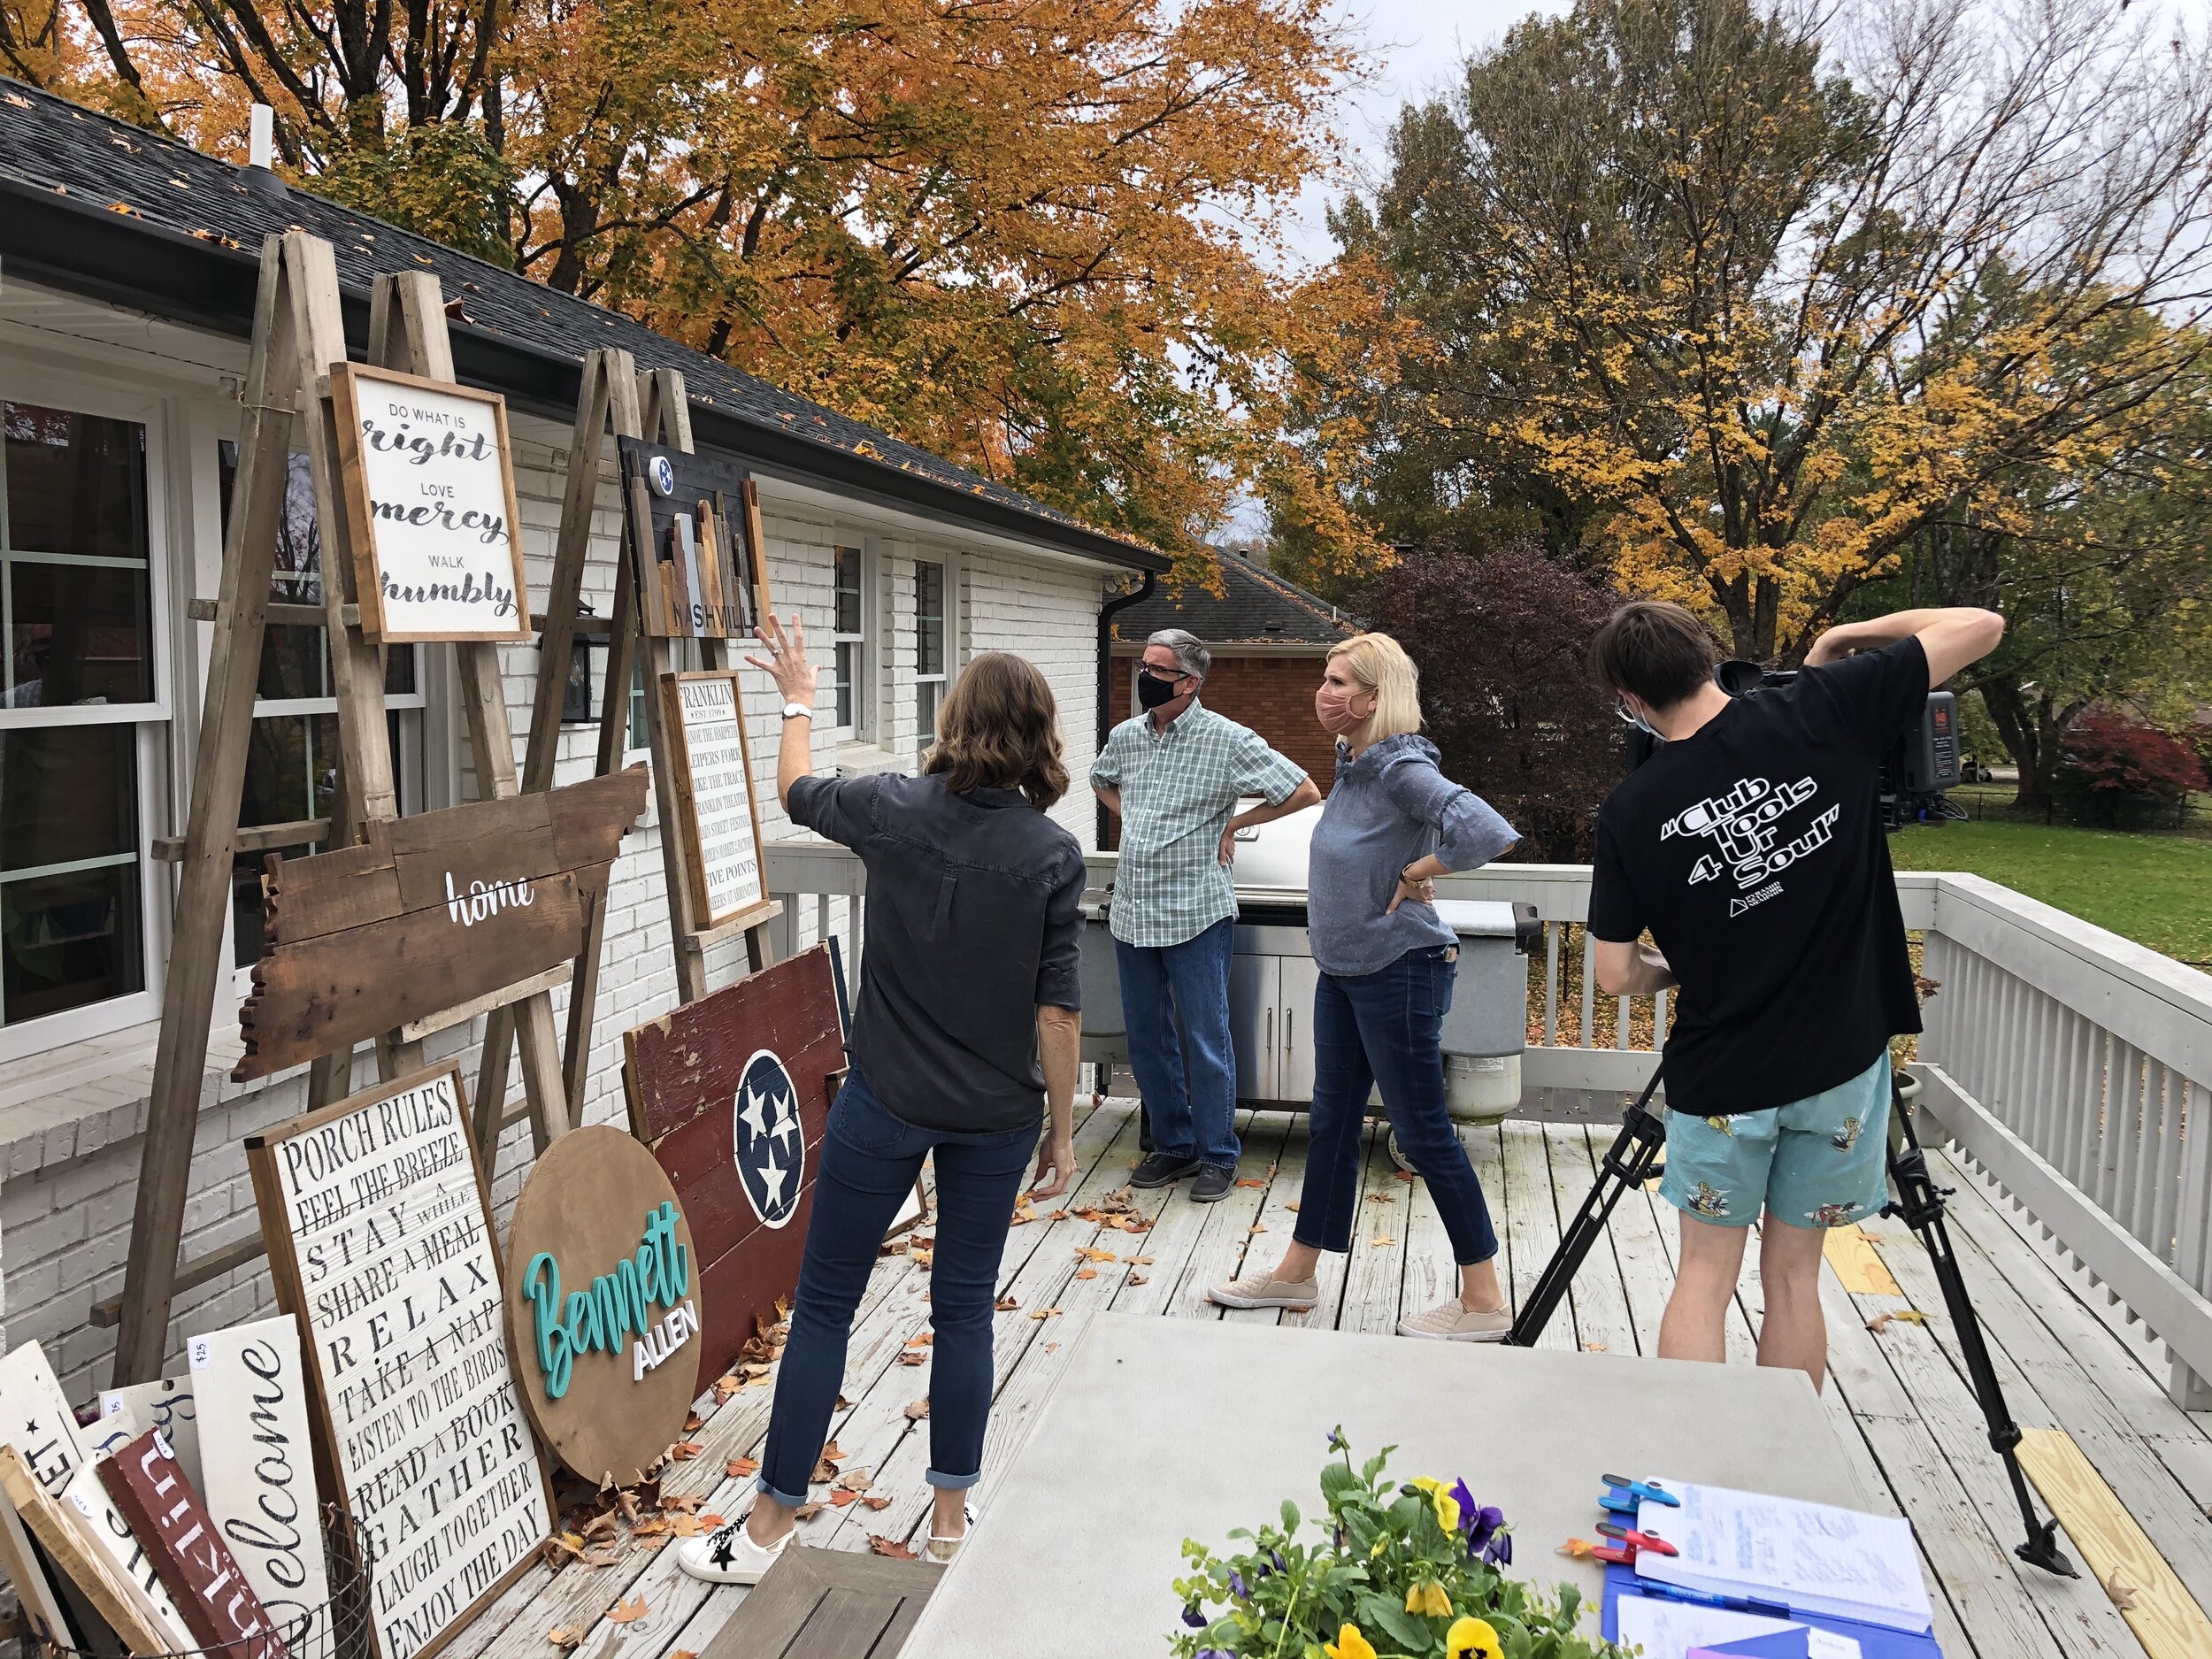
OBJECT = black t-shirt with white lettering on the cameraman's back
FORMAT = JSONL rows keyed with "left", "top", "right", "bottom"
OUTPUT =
{"left": 1591, "top": 640, "right": 1929, "bottom": 1118}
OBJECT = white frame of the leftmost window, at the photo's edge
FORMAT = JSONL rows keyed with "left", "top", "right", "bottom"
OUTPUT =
{"left": 0, "top": 373, "right": 177, "bottom": 1062}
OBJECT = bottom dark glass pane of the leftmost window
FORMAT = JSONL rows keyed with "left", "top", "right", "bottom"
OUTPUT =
{"left": 0, "top": 858, "right": 146, "bottom": 1025}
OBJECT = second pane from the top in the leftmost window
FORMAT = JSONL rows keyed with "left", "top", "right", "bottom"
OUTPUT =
{"left": 7, "top": 560, "right": 153, "bottom": 708}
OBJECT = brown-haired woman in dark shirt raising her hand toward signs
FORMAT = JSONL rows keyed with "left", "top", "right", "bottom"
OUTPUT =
{"left": 677, "top": 618, "right": 1084, "bottom": 1584}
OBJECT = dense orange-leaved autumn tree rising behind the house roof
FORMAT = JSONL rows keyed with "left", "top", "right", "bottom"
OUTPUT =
{"left": 0, "top": 0, "right": 1376, "bottom": 566}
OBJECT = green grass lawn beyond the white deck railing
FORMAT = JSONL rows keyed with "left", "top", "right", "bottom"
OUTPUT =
{"left": 1889, "top": 823, "right": 2212, "bottom": 967}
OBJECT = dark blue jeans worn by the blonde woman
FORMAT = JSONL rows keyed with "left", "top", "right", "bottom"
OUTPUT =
{"left": 1292, "top": 945, "right": 1498, "bottom": 1268}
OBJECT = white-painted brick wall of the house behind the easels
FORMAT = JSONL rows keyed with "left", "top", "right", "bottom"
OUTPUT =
{"left": 0, "top": 396, "right": 1102, "bottom": 1405}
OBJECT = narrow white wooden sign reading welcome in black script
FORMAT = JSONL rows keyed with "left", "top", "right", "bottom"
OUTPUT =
{"left": 184, "top": 1317, "right": 330, "bottom": 1628}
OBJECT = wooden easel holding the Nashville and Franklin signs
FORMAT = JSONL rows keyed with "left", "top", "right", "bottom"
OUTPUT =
{"left": 476, "top": 348, "right": 781, "bottom": 1175}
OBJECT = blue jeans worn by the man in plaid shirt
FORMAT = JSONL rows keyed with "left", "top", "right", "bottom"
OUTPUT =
{"left": 1113, "top": 916, "right": 1243, "bottom": 1168}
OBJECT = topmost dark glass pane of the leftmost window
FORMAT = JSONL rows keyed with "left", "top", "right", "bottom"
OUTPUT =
{"left": 0, "top": 403, "right": 146, "bottom": 560}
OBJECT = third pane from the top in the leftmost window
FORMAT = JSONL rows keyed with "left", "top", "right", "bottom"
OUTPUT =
{"left": 0, "top": 726, "right": 137, "bottom": 872}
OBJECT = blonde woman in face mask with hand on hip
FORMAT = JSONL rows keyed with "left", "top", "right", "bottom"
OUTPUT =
{"left": 1208, "top": 633, "right": 1520, "bottom": 1343}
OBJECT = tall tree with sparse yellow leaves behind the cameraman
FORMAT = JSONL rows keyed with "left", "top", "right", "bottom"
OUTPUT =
{"left": 1339, "top": 0, "right": 2212, "bottom": 662}
